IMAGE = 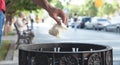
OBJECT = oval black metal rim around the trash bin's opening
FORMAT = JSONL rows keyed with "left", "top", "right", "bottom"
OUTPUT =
{"left": 19, "top": 42, "right": 113, "bottom": 54}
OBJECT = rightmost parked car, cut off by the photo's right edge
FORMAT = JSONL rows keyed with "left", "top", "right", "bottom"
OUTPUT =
{"left": 105, "top": 16, "right": 120, "bottom": 33}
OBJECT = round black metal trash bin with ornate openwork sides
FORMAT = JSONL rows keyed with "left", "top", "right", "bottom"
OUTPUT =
{"left": 19, "top": 42, "right": 113, "bottom": 65}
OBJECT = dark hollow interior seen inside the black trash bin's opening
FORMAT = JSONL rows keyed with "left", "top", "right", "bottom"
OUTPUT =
{"left": 21, "top": 43, "right": 106, "bottom": 52}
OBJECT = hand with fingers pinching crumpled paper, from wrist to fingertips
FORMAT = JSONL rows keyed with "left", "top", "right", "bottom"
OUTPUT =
{"left": 48, "top": 8, "right": 68, "bottom": 25}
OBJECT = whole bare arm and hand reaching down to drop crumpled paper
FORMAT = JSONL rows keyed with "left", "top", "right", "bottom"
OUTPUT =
{"left": 33, "top": 0, "right": 67, "bottom": 24}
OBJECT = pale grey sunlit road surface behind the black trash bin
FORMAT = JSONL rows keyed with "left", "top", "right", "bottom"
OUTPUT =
{"left": 33, "top": 23, "right": 120, "bottom": 65}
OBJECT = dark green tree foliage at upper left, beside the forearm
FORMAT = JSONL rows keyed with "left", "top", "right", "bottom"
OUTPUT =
{"left": 6, "top": 0, "right": 39, "bottom": 13}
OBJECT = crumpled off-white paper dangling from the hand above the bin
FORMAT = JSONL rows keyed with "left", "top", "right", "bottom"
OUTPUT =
{"left": 49, "top": 23, "right": 67, "bottom": 38}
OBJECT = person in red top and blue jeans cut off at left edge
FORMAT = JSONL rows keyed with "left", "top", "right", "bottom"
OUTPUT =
{"left": 0, "top": 0, "right": 6, "bottom": 48}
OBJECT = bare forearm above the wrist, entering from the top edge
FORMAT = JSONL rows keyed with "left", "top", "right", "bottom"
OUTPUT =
{"left": 33, "top": 0, "right": 54, "bottom": 12}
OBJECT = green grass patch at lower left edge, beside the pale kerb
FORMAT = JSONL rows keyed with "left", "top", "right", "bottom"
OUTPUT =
{"left": 0, "top": 40, "right": 11, "bottom": 61}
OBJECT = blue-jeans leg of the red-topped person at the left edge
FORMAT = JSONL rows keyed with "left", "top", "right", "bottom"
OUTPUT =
{"left": 0, "top": 10, "right": 5, "bottom": 46}
